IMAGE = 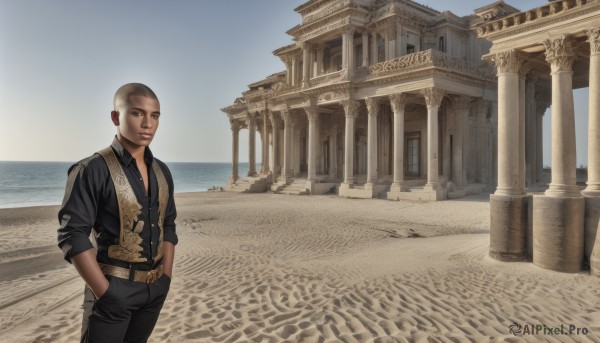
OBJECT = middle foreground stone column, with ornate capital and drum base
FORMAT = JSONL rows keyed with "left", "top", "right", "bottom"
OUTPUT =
{"left": 533, "top": 36, "right": 585, "bottom": 273}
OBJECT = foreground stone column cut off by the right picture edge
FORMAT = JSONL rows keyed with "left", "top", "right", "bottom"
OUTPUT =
{"left": 583, "top": 29, "right": 600, "bottom": 276}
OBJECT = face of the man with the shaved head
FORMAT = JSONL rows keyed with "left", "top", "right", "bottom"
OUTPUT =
{"left": 111, "top": 95, "right": 160, "bottom": 148}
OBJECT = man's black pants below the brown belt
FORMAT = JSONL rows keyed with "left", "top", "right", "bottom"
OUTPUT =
{"left": 81, "top": 274, "right": 171, "bottom": 343}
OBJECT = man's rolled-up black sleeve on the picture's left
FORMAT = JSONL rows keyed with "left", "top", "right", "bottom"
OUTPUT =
{"left": 57, "top": 164, "right": 97, "bottom": 263}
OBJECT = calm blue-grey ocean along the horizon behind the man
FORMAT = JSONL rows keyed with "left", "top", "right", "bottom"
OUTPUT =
{"left": 0, "top": 161, "right": 248, "bottom": 208}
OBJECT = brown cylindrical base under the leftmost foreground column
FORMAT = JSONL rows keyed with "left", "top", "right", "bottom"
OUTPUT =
{"left": 490, "top": 194, "right": 530, "bottom": 262}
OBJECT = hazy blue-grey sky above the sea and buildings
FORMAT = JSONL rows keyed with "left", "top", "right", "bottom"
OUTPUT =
{"left": 0, "top": 0, "right": 587, "bottom": 165}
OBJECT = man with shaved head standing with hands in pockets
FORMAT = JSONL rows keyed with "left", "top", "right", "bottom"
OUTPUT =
{"left": 58, "top": 83, "right": 177, "bottom": 343}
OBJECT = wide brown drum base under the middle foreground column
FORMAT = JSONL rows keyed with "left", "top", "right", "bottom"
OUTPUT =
{"left": 533, "top": 195, "right": 585, "bottom": 273}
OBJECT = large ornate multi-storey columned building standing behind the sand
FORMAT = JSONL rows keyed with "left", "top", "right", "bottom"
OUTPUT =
{"left": 222, "top": 0, "right": 508, "bottom": 200}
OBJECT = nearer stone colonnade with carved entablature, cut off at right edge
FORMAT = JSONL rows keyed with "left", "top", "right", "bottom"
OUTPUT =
{"left": 477, "top": 0, "right": 600, "bottom": 272}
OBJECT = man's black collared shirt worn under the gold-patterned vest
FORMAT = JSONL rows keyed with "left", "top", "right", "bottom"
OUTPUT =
{"left": 58, "top": 137, "right": 177, "bottom": 269}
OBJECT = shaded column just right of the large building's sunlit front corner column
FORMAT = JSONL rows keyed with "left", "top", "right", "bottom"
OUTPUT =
{"left": 450, "top": 95, "right": 473, "bottom": 187}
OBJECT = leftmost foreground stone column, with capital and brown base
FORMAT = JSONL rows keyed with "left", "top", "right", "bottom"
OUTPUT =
{"left": 490, "top": 50, "right": 529, "bottom": 261}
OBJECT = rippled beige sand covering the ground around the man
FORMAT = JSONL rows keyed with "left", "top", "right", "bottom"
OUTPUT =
{"left": 0, "top": 192, "right": 600, "bottom": 343}
